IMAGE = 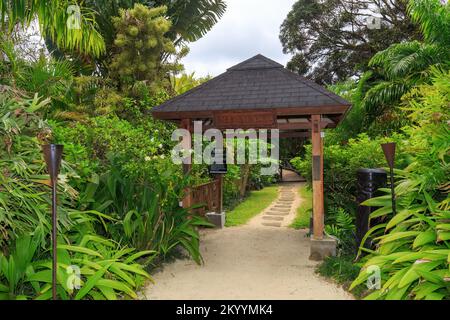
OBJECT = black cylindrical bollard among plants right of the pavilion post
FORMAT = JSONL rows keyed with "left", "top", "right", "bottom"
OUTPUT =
{"left": 356, "top": 169, "right": 387, "bottom": 248}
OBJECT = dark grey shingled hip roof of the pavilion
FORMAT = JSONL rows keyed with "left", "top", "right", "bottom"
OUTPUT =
{"left": 152, "top": 54, "right": 350, "bottom": 113}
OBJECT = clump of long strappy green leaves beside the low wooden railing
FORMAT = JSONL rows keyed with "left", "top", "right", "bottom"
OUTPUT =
{"left": 84, "top": 160, "right": 211, "bottom": 263}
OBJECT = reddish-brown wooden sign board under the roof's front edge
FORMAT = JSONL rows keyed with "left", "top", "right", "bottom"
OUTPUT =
{"left": 214, "top": 111, "right": 276, "bottom": 129}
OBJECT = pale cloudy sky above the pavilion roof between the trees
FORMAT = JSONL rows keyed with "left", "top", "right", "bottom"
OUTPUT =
{"left": 182, "top": 0, "right": 295, "bottom": 76}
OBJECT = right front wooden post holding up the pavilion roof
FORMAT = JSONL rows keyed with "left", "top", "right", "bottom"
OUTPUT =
{"left": 311, "top": 115, "right": 325, "bottom": 240}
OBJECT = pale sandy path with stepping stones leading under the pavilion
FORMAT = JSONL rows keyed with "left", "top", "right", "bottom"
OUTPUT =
{"left": 145, "top": 184, "right": 352, "bottom": 300}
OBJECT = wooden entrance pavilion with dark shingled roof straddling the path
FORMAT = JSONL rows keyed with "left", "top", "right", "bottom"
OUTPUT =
{"left": 152, "top": 55, "right": 351, "bottom": 260}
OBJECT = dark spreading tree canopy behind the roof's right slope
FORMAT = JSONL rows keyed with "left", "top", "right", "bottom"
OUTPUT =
{"left": 280, "top": 0, "right": 420, "bottom": 84}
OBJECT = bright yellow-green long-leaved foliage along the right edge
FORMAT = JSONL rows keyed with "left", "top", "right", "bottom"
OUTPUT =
{"left": 351, "top": 70, "right": 450, "bottom": 300}
